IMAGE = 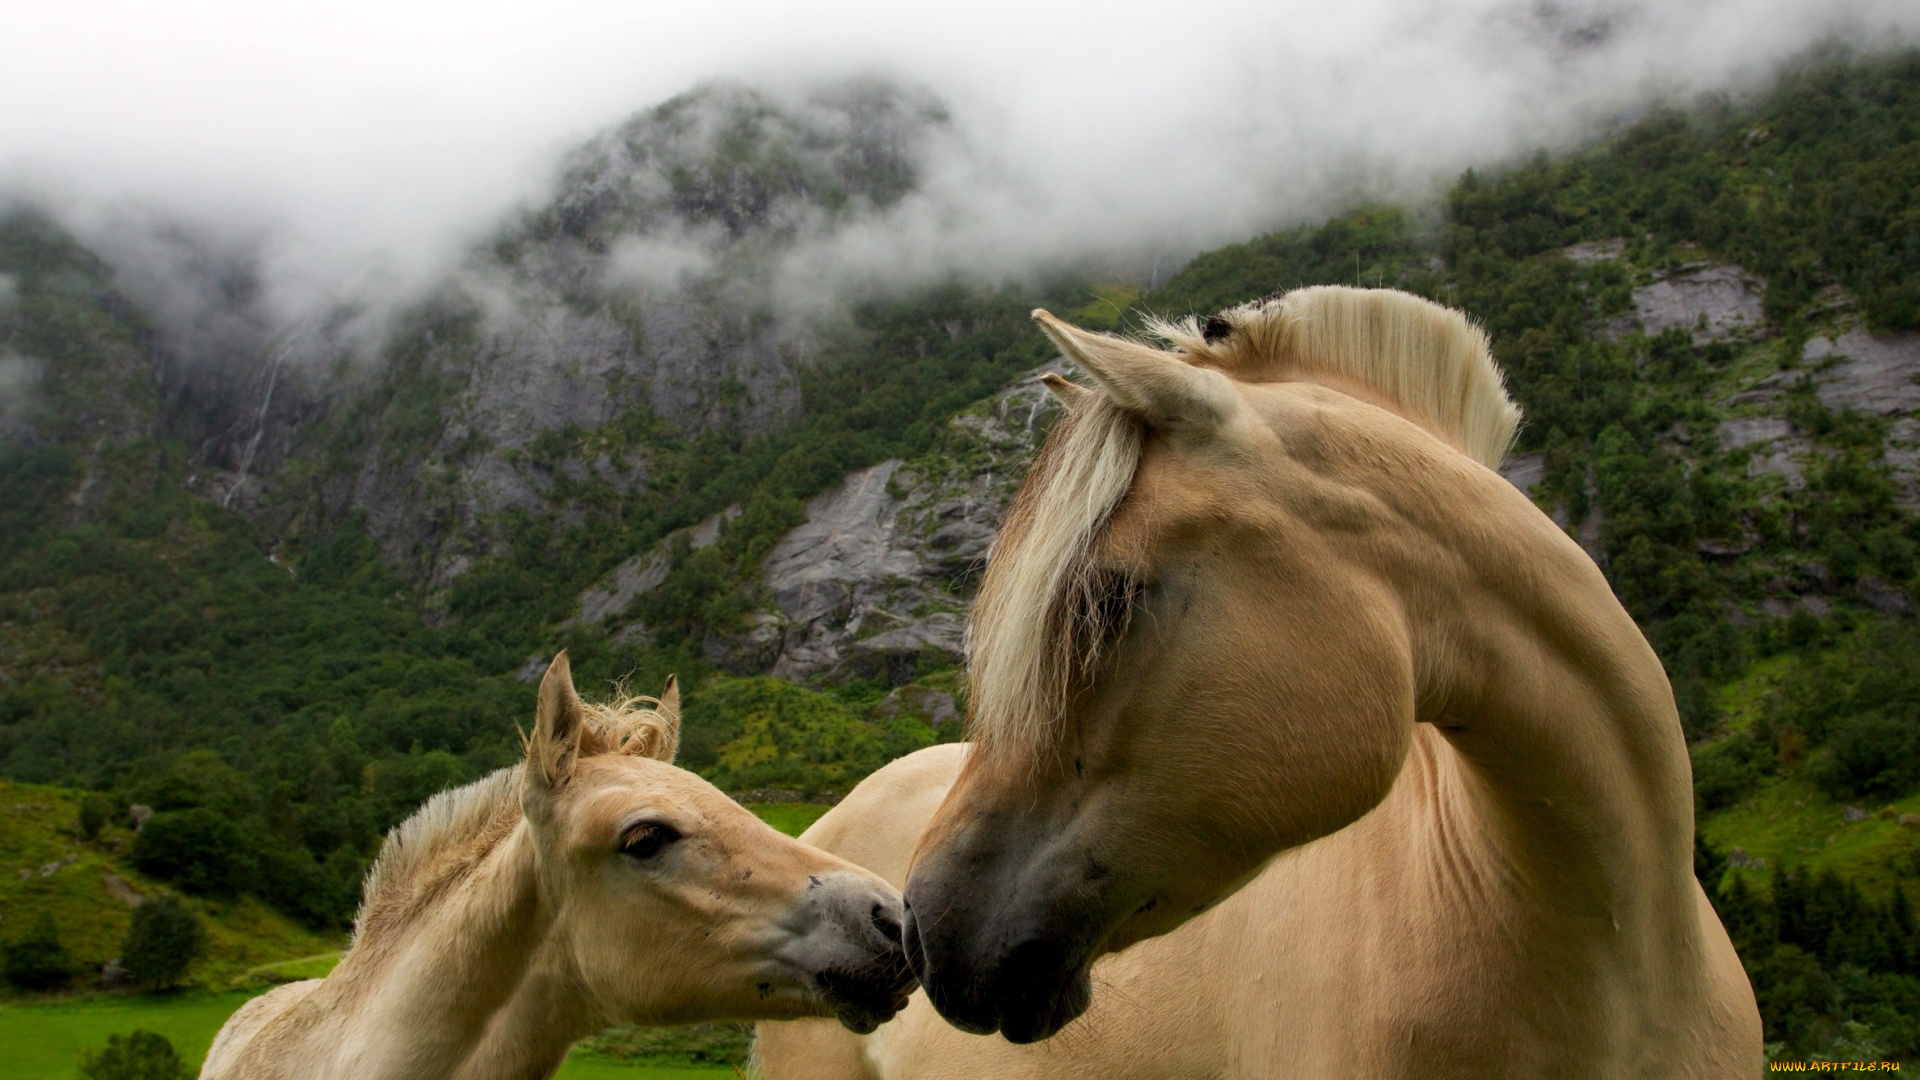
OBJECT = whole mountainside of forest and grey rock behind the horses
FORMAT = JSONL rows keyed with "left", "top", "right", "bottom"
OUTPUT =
{"left": 0, "top": 46, "right": 1920, "bottom": 1057}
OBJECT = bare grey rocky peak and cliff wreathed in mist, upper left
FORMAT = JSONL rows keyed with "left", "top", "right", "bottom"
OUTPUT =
{"left": 178, "top": 83, "right": 945, "bottom": 592}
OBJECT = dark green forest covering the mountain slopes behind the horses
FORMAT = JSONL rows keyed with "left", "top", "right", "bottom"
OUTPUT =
{"left": 0, "top": 44, "right": 1920, "bottom": 1059}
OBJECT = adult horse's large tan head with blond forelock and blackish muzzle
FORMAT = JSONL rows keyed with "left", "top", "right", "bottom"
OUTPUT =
{"left": 906, "top": 290, "right": 1513, "bottom": 1042}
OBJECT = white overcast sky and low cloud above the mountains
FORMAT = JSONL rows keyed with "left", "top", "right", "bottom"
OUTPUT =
{"left": 0, "top": 0, "right": 1920, "bottom": 311}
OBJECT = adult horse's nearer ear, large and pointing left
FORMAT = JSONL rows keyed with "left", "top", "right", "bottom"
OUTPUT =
{"left": 1033, "top": 309, "right": 1240, "bottom": 430}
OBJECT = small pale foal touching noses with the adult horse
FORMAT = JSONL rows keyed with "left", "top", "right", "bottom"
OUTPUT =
{"left": 200, "top": 653, "right": 912, "bottom": 1080}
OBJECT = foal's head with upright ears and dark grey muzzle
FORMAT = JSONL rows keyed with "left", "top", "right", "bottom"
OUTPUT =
{"left": 520, "top": 653, "right": 912, "bottom": 1032}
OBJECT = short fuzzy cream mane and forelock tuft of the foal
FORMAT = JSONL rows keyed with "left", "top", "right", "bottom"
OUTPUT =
{"left": 353, "top": 692, "right": 672, "bottom": 940}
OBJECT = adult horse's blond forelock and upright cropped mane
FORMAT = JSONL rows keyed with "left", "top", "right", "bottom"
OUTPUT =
{"left": 968, "top": 286, "right": 1521, "bottom": 757}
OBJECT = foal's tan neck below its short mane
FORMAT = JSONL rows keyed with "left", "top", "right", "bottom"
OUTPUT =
{"left": 318, "top": 822, "right": 564, "bottom": 1078}
